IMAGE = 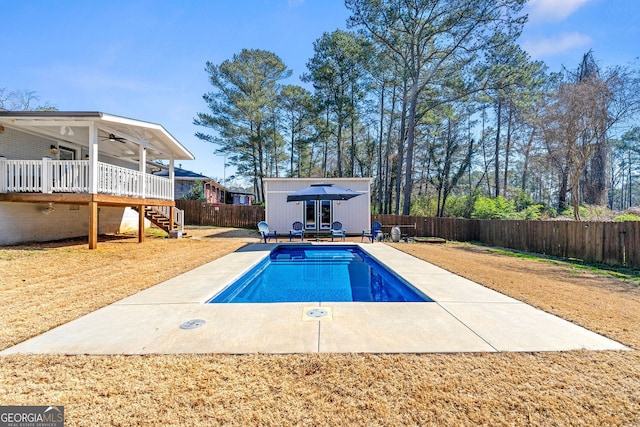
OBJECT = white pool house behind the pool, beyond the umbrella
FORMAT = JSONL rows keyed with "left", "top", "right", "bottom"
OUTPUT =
{"left": 264, "top": 178, "right": 371, "bottom": 235}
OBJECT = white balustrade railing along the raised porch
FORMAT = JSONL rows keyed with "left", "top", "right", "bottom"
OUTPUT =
{"left": 0, "top": 157, "right": 173, "bottom": 200}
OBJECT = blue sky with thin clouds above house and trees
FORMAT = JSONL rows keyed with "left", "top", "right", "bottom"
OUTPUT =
{"left": 0, "top": 0, "right": 640, "bottom": 184}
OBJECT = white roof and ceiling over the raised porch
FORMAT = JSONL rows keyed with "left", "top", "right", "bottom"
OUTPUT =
{"left": 0, "top": 111, "right": 194, "bottom": 160}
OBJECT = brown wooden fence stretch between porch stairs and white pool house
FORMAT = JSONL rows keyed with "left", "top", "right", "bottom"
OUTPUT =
{"left": 176, "top": 200, "right": 264, "bottom": 230}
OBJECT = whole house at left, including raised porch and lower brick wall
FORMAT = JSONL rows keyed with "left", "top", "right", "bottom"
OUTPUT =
{"left": 0, "top": 111, "right": 194, "bottom": 249}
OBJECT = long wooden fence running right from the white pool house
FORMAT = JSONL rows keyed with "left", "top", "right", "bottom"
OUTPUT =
{"left": 371, "top": 215, "right": 640, "bottom": 268}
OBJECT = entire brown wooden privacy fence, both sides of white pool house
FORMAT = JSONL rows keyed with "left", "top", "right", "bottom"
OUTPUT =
{"left": 176, "top": 204, "right": 640, "bottom": 268}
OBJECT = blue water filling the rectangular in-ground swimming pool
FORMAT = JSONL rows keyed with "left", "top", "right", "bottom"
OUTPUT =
{"left": 209, "top": 245, "right": 432, "bottom": 303}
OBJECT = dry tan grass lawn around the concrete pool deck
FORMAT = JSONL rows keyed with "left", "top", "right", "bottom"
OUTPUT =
{"left": 0, "top": 228, "right": 640, "bottom": 426}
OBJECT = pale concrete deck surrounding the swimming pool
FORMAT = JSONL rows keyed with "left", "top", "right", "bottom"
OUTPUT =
{"left": 0, "top": 243, "right": 628, "bottom": 354}
